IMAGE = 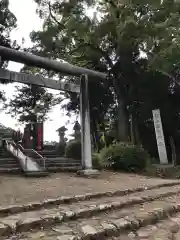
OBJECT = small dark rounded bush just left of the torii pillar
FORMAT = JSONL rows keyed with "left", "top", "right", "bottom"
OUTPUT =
{"left": 65, "top": 140, "right": 81, "bottom": 160}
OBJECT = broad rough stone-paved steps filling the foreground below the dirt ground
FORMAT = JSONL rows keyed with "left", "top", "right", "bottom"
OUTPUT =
{"left": 0, "top": 176, "right": 180, "bottom": 240}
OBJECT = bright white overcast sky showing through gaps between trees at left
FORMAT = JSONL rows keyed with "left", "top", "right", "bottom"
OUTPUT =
{"left": 0, "top": 0, "right": 75, "bottom": 141}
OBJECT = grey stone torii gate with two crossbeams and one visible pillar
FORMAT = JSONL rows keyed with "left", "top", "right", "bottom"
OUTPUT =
{"left": 0, "top": 46, "right": 107, "bottom": 175}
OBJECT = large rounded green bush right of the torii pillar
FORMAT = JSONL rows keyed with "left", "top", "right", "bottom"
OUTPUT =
{"left": 100, "top": 143, "right": 149, "bottom": 172}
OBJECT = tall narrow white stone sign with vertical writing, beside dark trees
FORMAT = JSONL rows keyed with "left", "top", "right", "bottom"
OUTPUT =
{"left": 152, "top": 109, "right": 168, "bottom": 164}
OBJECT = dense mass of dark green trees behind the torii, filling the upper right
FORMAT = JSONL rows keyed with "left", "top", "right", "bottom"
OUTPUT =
{"left": 5, "top": 0, "right": 180, "bottom": 159}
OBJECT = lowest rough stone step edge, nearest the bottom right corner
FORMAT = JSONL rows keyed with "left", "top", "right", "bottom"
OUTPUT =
{"left": 60, "top": 204, "right": 180, "bottom": 240}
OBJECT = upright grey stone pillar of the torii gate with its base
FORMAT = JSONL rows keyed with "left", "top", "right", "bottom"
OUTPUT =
{"left": 79, "top": 75, "right": 98, "bottom": 176}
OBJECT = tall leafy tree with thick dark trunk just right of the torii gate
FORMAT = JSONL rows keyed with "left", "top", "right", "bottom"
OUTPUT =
{"left": 26, "top": 0, "right": 180, "bottom": 145}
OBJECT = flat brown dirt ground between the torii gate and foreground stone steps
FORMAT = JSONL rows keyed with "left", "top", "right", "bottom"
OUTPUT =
{"left": 0, "top": 172, "right": 178, "bottom": 206}
